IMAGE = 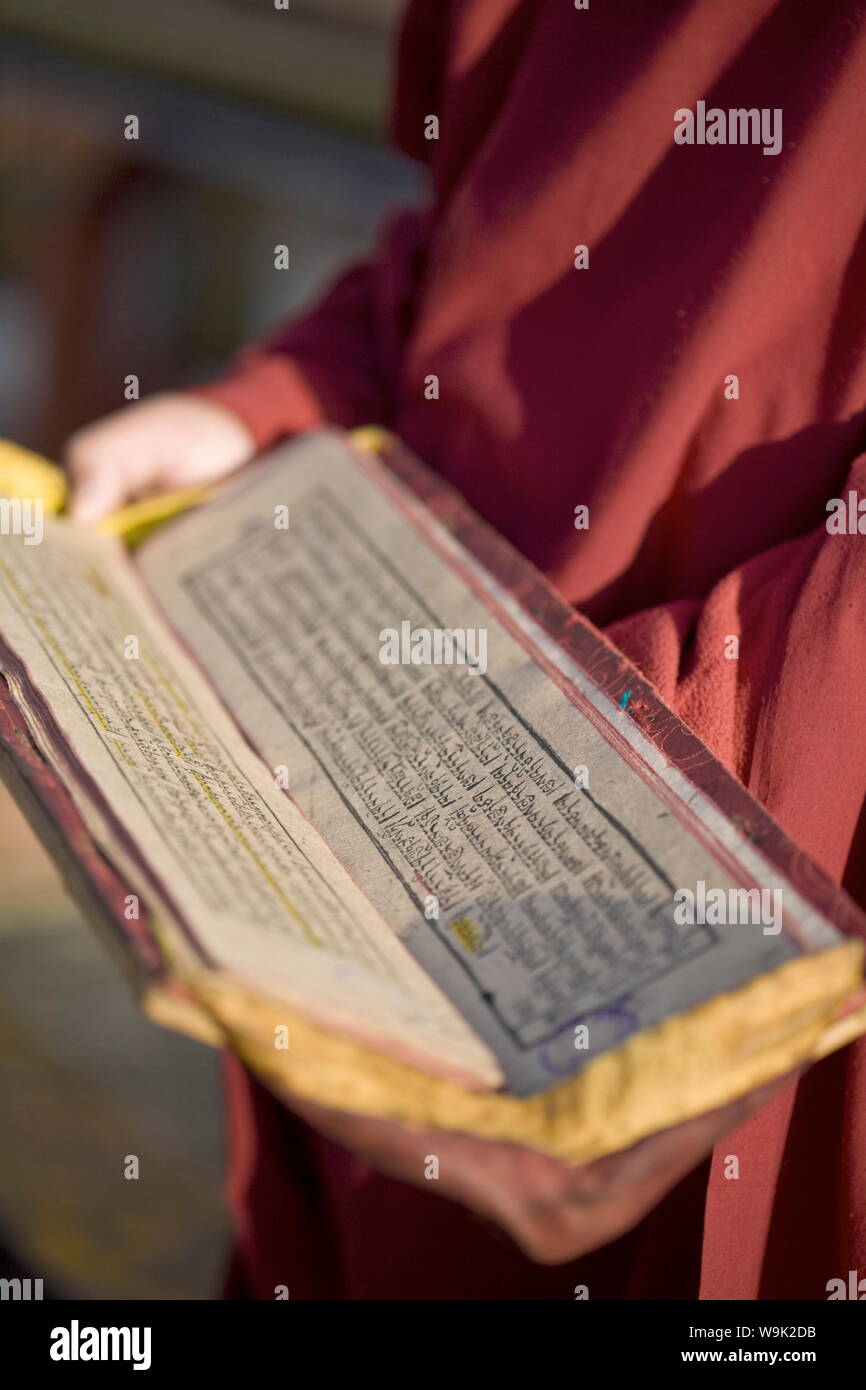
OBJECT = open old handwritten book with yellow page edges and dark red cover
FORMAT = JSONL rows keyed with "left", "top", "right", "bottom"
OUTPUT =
{"left": 0, "top": 431, "right": 866, "bottom": 1162}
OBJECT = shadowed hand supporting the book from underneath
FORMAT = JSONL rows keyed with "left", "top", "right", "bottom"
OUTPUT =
{"left": 284, "top": 1083, "right": 781, "bottom": 1265}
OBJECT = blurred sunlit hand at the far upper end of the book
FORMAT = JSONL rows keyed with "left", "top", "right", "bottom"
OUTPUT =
{"left": 64, "top": 392, "right": 256, "bottom": 524}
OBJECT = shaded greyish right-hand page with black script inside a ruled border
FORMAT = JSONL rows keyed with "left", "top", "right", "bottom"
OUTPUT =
{"left": 138, "top": 434, "right": 835, "bottom": 1093}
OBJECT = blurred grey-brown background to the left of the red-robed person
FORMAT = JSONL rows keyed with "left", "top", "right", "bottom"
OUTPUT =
{"left": 0, "top": 0, "right": 417, "bottom": 1298}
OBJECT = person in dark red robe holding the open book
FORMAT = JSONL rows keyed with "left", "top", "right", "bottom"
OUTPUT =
{"left": 68, "top": 0, "right": 866, "bottom": 1300}
